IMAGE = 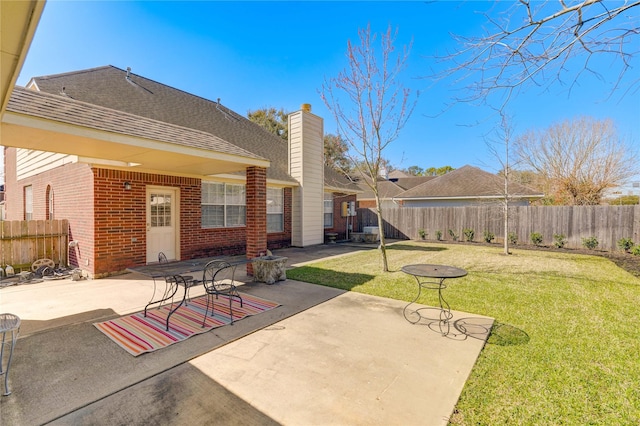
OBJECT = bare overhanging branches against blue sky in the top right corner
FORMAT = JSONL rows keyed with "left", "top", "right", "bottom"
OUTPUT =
{"left": 438, "top": 0, "right": 640, "bottom": 110}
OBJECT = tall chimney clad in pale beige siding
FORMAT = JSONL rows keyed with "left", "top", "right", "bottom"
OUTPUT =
{"left": 289, "top": 111, "right": 324, "bottom": 247}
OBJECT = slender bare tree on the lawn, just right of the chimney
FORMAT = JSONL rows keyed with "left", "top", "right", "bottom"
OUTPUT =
{"left": 320, "top": 25, "right": 415, "bottom": 272}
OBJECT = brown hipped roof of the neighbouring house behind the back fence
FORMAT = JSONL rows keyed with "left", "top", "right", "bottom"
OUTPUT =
{"left": 395, "top": 165, "right": 543, "bottom": 199}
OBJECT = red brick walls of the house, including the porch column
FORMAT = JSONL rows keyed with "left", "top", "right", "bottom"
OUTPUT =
{"left": 5, "top": 148, "right": 291, "bottom": 277}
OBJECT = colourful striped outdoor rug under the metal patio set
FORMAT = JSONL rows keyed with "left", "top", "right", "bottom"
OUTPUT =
{"left": 93, "top": 293, "right": 280, "bottom": 356}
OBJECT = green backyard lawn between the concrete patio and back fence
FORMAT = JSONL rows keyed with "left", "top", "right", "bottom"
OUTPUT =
{"left": 287, "top": 242, "right": 640, "bottom": 425}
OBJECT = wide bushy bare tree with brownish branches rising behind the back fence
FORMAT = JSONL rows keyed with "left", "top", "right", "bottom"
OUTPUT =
{"left": 515, "top": 117, "right": 638, "bottom": 205}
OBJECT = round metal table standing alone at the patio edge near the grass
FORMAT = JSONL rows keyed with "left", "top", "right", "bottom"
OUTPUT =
{"left": 402, "top": 264, "right": 467, "bottom": 336}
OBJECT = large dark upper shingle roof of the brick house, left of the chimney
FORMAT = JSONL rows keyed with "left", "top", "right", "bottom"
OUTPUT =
{"left": 23, "top": 65, "right": 352, "bottom": 190}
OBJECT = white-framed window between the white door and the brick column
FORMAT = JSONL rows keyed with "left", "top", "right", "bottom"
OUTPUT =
{"left": 201, "top": 182, "right": 247, "bottom": 228}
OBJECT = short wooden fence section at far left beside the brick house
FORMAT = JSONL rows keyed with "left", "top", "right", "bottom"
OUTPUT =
{"left": 0, "top": 219, "right": 69, "bottom": 271}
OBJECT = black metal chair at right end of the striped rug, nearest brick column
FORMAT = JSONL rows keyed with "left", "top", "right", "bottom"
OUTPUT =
{"left": 202, "top": 260, "right": 242, "bottom": 327}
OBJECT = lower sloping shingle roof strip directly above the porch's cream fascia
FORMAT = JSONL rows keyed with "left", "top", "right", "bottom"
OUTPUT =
{"left": 7, "top": 87, "right": 263, "bottom": 159}
